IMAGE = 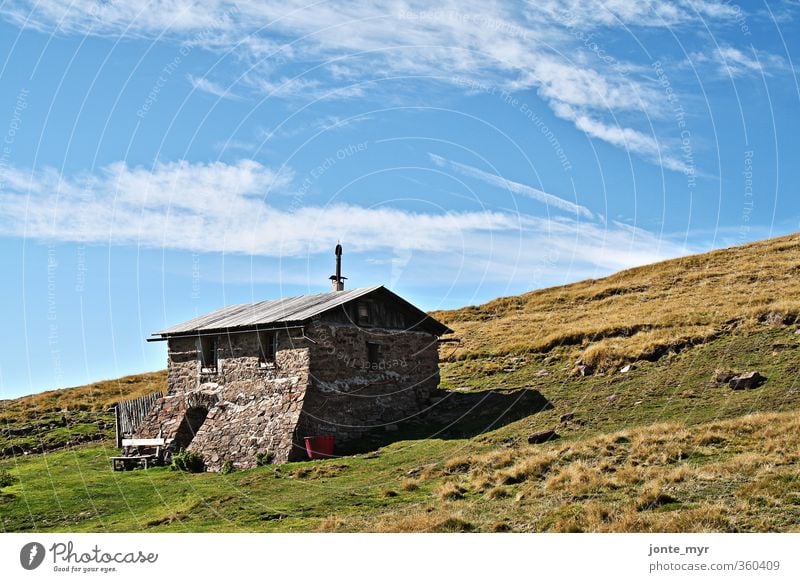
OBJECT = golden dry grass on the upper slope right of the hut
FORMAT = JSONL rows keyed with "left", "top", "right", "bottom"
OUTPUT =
{"left": 433, "top": 234, "right": 800, "bottom": 371}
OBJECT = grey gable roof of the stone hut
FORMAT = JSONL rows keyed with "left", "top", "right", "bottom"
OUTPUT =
{"left": 148, "top": 285, "right": 452, "bottom": 341}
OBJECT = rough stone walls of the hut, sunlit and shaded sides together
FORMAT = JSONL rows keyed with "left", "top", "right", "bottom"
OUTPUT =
{"left": 137, "top": 318, "right": 439, "bottom": 471}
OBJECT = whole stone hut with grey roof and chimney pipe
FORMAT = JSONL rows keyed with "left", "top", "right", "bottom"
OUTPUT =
{"left": 136, "top": 246, "right": 451, "bottom": 471}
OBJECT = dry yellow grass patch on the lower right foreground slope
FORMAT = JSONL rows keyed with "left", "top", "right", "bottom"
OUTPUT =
{"left": 330, "top": 411, "right": 800, "bottom": 532}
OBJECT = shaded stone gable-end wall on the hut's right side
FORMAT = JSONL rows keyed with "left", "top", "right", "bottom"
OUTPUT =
{"left": 300, "top": 320, "right": 439, "bottom": 451}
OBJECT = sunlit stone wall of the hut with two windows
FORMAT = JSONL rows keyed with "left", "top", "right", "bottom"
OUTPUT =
{"left": 137, "top": 331, "right": 309, "bottom": 471}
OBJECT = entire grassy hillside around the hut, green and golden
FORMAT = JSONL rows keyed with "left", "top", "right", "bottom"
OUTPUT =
{"left": 0, "top": 235, "right": 800, "bottom": 531}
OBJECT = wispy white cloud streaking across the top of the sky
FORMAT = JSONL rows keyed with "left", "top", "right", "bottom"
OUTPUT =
{"left": 4, "top": 0, "right": 752, "bottom": 171}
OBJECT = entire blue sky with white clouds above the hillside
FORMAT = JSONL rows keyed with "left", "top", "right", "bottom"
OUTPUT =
{"left": 0, "top": 0, "right": 800, "bottom": 398}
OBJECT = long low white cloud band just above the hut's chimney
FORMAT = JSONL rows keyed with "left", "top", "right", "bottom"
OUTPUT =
{"left": 0, "top": 160, "right": 687, "bottom": 287}
